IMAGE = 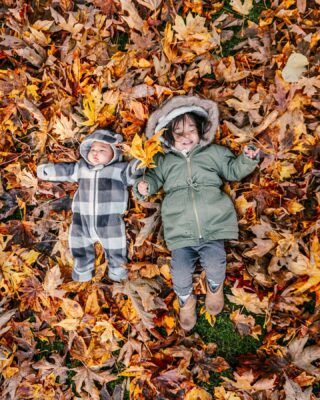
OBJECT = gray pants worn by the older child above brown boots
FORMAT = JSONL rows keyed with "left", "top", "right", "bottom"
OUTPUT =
{"left": 171, "top": 239, "right": 226, "bottom": 297}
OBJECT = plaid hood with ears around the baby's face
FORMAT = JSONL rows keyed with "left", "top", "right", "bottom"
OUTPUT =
{"left": 80, "top": 129, "right": 123, "bottom": 165}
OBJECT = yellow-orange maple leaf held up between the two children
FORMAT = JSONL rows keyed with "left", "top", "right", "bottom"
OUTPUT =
{"left": 129, "top": 130, "right": 163, "bottom": 168}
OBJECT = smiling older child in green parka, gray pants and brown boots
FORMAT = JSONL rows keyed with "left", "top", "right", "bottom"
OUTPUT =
{"left": 134, "top": 96, "right": 259, "bottom": 330}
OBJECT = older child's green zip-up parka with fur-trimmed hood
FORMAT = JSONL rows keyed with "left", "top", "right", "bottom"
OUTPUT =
{"left": 134, "top": 96, "right": 258, "bottom": 250}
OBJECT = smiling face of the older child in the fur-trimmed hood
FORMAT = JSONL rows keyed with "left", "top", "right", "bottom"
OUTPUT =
{"left": 172, "top": 116, "right": 200, "bottom": 151}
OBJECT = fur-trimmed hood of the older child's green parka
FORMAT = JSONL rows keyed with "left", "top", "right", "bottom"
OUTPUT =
{"left": 146, "top": 96, "right": 219, "bottom": 146}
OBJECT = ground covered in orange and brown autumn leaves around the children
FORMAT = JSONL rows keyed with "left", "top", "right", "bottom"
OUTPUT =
{"left": 0, "top": 0, "right": 320, "bottom": 400}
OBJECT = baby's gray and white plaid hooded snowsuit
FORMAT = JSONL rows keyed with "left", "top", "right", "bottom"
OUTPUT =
{"left": 37, "top": 129, "right": 140, "bottom": 282}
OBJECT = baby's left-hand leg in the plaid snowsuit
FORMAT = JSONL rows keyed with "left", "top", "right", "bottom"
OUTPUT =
{"left": 69, "top": 223, "right": 95, "bottom": 282}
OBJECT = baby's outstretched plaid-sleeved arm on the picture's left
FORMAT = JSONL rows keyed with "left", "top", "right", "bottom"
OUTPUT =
{"left": 37, "top": 163, "right": 79, "bottom": 182}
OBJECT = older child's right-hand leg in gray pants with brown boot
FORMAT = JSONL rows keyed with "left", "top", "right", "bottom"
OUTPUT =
{"left": 198, "top": 240, "right": 226, "bottom": 315}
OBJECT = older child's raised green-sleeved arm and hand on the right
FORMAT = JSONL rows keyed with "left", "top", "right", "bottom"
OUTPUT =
{"left": 220, "top": 145, "right": 260, "bottom": 181}
